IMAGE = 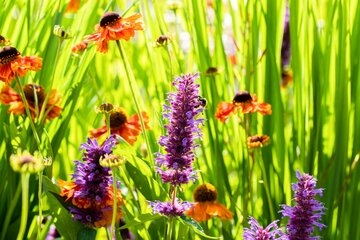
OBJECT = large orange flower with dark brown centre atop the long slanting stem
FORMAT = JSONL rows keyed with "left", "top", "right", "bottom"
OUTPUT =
{"left": 75, "top": 12, "right": 143, "bottom": 53}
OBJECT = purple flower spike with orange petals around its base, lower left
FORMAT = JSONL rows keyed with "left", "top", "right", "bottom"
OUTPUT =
{"left": 58, "top": 136, "right": 122, "bottom": 227}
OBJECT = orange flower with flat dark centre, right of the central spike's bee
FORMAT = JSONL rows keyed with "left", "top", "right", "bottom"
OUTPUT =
{"left": 215, "top": 91, "right": 272, "bottom": 122}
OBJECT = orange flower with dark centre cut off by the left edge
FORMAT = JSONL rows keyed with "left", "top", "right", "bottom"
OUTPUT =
{"left": 0, "top": 46, "right": 42, "bottom": 84}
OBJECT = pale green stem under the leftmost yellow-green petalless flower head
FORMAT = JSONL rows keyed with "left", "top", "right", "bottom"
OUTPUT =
{"left": 16, "top": 173, "right": 30, "bottom": 240}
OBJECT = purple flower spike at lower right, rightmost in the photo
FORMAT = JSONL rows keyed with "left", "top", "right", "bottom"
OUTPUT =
{"left": 280, "top": 171, "right": 325, "bottom": 240}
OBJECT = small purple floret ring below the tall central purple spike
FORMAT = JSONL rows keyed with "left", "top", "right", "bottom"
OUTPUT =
{"left": 149, "top": 198, "right": 193, "bottom": 217}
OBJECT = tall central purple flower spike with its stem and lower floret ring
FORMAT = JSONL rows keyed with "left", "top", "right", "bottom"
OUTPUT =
{"left": 150, "top": 73, "right": 204, "bottom": 239}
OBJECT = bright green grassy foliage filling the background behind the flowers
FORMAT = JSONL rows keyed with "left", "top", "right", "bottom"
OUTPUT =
{"left": 0, "top": 0, "right": 360, "bottom": 240}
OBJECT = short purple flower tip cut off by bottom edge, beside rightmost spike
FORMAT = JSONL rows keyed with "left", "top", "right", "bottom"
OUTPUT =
{"left": 244, "top": 217, "right": 288, "bottom": 240}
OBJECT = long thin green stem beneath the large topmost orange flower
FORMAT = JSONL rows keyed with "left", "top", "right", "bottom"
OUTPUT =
{"left": 116, "top": 40, "right": 153, "bottom": 162}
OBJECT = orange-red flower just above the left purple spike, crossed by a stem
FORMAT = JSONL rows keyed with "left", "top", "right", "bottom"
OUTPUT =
{"left": 90, "top": 107, "right": 150, "bottom": 144}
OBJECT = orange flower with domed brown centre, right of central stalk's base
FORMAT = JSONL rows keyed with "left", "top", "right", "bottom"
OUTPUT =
{"left": 185, "top": 183, "right": 233, "bottom": 222}
